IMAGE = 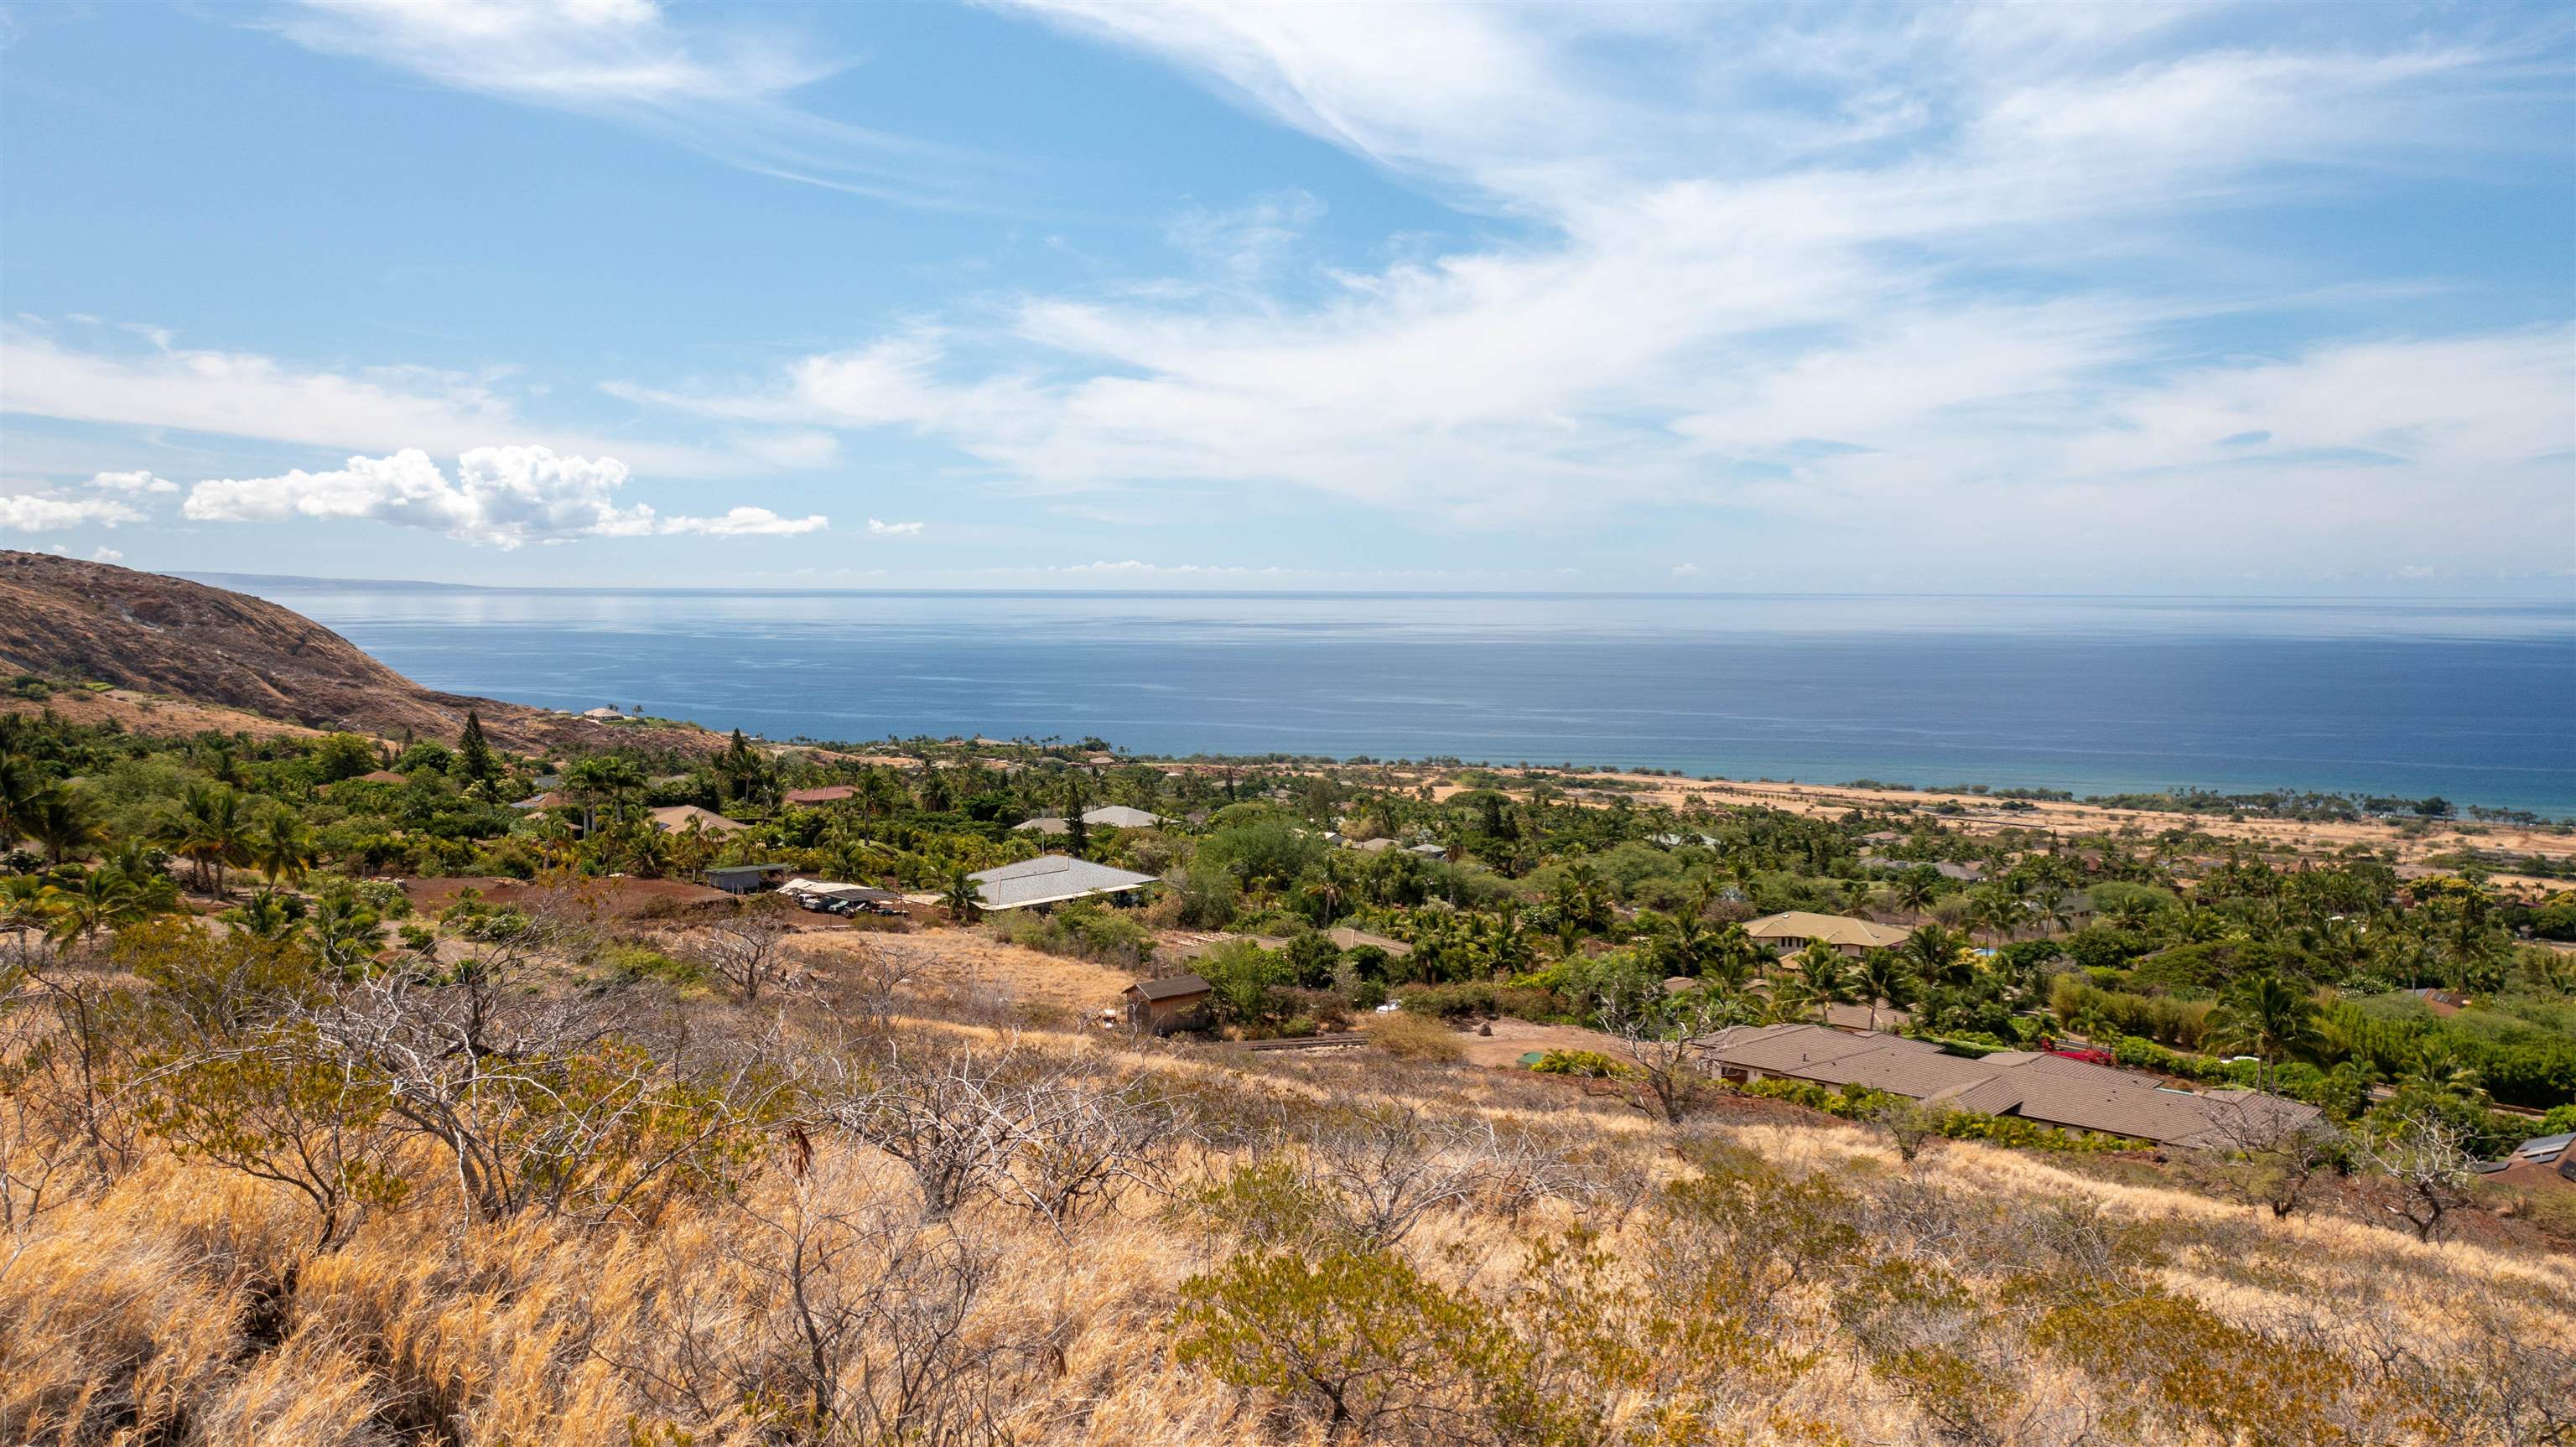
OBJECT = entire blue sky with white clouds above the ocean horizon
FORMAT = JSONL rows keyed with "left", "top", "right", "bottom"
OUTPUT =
{"left": 0, "top": 0, "right": 2576, "bottom": 598}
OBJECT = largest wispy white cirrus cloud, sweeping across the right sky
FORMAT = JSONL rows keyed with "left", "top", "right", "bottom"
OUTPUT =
{"left": 621, "top": 0, "right": 2576, "bottom": 564}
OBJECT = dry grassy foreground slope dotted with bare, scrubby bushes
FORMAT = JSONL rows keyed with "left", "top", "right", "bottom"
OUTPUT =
{"left": 0, "top": 911, "right": 2576, "bottom": 1447}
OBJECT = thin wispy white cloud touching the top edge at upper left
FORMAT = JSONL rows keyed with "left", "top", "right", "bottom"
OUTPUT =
{"left": 262, "top": 0, "right": 981, "bottom": 206}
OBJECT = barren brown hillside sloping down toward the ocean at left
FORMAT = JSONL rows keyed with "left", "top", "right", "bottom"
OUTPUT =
{"left": 0, "top": 551, "right": 719, "bottom": 752}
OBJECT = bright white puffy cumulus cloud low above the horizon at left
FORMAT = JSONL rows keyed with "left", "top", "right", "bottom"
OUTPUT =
{"left": 180, "top": 448, "right": 824, "bottom": 548}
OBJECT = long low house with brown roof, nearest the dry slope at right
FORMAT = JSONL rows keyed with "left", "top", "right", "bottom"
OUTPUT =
{"left": 1695, "top": 1024, "right": 2319, "bottom": 1146}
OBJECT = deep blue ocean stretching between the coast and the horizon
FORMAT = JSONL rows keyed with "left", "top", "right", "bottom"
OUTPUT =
{"left": 209, "top": 579, "right": 2576, "bottom": 817}
